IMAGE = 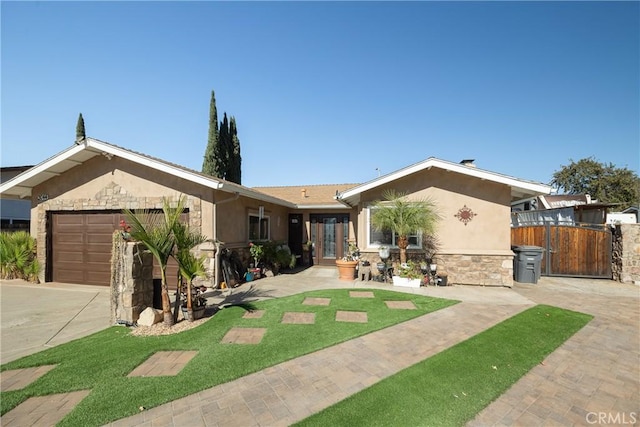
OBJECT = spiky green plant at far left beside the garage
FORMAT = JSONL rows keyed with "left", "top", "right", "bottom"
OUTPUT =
{"left": 0, "top": 231, "right": 40, "bottom": 282}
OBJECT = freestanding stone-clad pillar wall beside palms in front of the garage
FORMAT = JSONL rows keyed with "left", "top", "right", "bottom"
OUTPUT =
{"left": 111, "top": 241, "right": 154, "bottom": 323}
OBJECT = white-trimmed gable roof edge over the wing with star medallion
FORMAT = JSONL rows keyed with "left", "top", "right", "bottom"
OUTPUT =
{"left": 336, "top": 157, "right": 551, "bottom": 206}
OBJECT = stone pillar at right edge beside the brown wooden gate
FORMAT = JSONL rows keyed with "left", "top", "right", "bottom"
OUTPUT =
{"left": 612, "top": 224, "right": 640, "bottom": 285}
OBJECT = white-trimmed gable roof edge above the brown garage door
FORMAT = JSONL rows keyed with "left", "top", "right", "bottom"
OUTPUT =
{"left": 0, "top": 138, "right": 295, "bottom": 207}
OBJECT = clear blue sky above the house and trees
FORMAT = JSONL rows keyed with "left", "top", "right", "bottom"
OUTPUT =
{"left": 0, "top": 1, "right": 640, "bottom": 187}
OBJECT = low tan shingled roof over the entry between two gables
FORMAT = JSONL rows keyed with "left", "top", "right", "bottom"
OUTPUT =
{"left": 252, "top": 184, "right": 358, "bottom": 209}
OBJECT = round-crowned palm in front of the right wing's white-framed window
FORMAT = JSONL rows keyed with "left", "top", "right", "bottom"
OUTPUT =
{"left": 371, "top": 190, "right": 440, "bottom": 263}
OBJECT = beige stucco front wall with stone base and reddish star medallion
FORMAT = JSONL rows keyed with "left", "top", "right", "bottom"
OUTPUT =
{"left": 358, "top": 169, "right": 513, "bottom": 286}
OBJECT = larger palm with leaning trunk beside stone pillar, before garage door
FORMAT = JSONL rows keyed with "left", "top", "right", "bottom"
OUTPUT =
{"left": 124, "top": 197, "right": 185, "bottom": 326}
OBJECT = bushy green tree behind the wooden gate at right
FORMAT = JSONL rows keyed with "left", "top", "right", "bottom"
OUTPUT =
{"left": 551, "top": 157, "right": 640, "bottom": 208}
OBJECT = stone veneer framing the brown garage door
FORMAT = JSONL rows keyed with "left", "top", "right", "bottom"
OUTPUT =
{"left": 36, "top": 182, "right": 202, "bottom": 283}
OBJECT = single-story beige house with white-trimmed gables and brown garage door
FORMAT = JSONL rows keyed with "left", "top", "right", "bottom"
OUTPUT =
{"left": 0, "top": 138, "right": 551, "bottom": 286}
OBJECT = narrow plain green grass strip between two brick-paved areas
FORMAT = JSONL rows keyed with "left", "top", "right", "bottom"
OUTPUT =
{"left": 296, "top": 305, "right": 593, "bottom": 427}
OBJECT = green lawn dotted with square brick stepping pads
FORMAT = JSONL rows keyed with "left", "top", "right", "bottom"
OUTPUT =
{"left": 0, "top": 289, "right": 456, "bottom": 427}
